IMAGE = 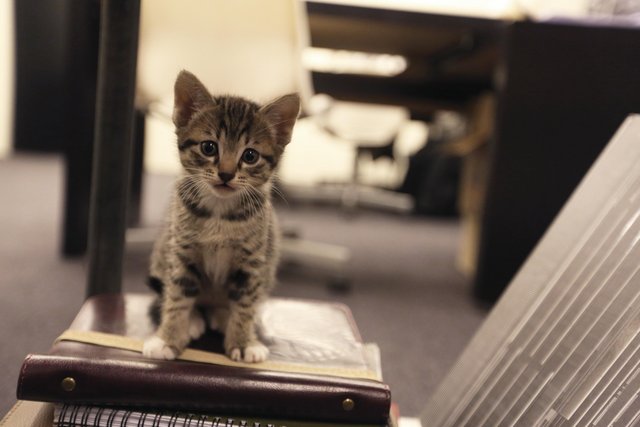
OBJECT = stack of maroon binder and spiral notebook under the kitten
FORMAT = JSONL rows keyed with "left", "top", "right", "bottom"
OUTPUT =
{"left": 12, "top": 294, "right": 394, "bottom": 427}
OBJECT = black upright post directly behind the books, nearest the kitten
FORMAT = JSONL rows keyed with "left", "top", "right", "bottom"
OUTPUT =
{"left": 87, "top": 0, "right": 140, "bottom": 296}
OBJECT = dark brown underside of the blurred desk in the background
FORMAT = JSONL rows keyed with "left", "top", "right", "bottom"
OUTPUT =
{"left": 307, "top": 1, "right": 506, "bottom": 116}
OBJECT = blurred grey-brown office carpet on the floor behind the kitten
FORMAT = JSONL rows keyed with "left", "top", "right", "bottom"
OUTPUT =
{"left": 0, "top": 155, "right": 486, "bottom": 416}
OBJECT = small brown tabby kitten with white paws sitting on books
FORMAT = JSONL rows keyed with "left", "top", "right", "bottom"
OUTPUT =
{"left": 143, "top": 71, "right": 300, "bottom": 362}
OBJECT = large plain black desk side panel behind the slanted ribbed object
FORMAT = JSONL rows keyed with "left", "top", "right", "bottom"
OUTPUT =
{"left": 475, "top": 22, "right": 640, "bottom": 301}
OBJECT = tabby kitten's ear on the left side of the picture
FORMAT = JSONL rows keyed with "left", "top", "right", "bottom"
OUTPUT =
{"left": 173, "top": 70, "right": 213, "bottom": 127}
